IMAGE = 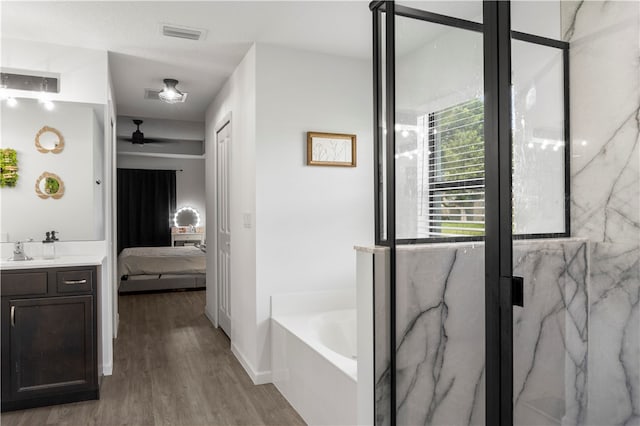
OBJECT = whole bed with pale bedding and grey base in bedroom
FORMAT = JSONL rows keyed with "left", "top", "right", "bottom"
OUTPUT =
{"left": 118, "top": 246, "right": 207, "bottom": 293}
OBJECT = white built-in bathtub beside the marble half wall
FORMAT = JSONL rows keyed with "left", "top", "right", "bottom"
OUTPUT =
{"left": 271, "top": 290, "right": 358, "bottom": 425}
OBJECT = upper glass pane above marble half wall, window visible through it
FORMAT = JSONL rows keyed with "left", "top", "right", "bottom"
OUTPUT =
{"left": 395, "top": 17, "right": 484, "bottom": 240}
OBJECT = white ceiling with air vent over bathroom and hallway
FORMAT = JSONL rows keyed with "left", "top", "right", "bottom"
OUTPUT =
{"left": 0, "top": 1, "right": 372, "bottom": 121}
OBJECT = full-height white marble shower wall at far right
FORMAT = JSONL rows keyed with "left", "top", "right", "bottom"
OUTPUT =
{"left": 562, "top": 1, "right": 640, "bottom": 426}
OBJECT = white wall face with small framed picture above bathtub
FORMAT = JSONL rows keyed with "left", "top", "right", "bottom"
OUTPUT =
{"left": 256, "top": 44, "right": 374, "bottom": 372}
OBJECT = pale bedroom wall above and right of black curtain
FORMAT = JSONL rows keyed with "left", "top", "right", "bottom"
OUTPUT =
{"left": 117, "top": 155, "right": 207, "bottom": 226}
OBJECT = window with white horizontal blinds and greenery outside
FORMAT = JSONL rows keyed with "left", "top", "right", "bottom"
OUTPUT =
{"left": 418, "top": 99, "right": 484, "bottom": 237}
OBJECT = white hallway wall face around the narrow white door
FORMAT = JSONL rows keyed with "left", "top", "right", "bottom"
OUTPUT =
{"left": 205, "top": 46, "right": 257, "bottom": 378}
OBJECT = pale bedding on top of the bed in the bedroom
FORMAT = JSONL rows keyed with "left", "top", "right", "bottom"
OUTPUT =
{"left": 118, "top": 246, "right": 207, "bottom": 276}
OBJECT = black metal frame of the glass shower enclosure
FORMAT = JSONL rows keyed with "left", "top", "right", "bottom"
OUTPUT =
{"left": 369, "top": 0, "right": 570, "bottom": 426}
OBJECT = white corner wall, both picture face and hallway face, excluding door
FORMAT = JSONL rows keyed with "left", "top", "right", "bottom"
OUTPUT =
{"left": 206, "top": 44, "right": 374, "bottom": 383}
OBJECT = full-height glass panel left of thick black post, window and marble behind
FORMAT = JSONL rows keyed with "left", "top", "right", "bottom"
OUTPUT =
{"left": 393, "top": 16, "right": 485, "bottom": 425}
